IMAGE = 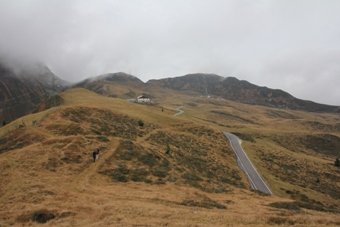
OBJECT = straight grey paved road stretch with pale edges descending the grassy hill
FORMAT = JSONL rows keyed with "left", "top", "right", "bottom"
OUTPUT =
{"left": 223, "top": 132, "right": 273, "bottom": 194}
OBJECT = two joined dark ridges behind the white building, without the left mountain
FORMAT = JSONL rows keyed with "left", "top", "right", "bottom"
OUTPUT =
{"left": 75, "top": 73, "right": 340, "bottom": 113}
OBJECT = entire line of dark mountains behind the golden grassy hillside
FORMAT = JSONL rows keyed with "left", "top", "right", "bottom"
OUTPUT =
{"left": 0, "top": 62, "right": 340, "bottom": 122}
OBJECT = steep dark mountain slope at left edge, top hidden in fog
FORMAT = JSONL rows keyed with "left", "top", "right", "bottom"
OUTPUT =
{"left": 0, "top": 61, "right": 68, "bottom": 123}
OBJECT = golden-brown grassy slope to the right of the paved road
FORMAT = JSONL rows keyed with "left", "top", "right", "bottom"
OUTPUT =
{"left": 178, "top": 99, "right": 340, "bottom": 207}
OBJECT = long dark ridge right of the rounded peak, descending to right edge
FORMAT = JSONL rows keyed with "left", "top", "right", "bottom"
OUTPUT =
{"left": 148, "top": 73, "right": 340, "bottom": 113}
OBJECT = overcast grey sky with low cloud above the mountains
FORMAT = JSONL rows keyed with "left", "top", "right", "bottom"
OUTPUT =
{"left": 0, "top": 0, "right": 340, "bottom": 105}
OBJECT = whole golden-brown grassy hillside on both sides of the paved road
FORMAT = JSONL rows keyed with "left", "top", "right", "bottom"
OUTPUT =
{"left": 0, "top": 88, "right": 340, "bottom": 226}
